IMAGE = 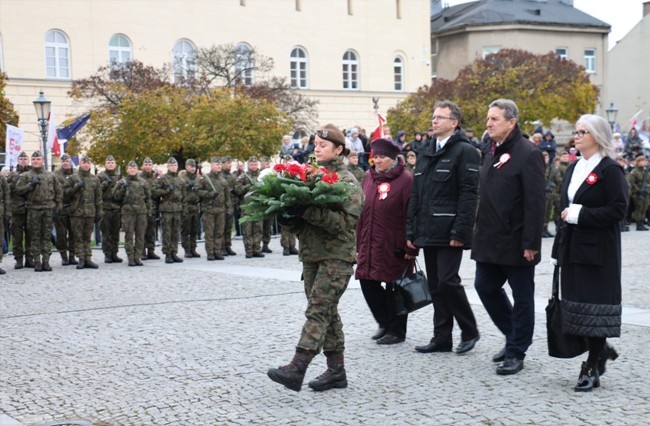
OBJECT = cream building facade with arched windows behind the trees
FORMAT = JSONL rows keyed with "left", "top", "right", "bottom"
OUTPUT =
{"left": 0, "top": 0, "right": 431, "bottom": 150}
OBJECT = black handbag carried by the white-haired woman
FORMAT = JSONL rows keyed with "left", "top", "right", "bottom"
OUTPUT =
{"left": 546, "top": 266, "right": 588, "bottom": 358}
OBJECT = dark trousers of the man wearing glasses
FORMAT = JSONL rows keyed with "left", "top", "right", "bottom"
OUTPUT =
{"left": 424, "top": 247, "right": 478, "bottom": 345}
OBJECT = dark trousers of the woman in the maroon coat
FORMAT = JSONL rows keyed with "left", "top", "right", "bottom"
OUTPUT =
{"left": 359, "top": 280, "right": 408, "bottom": 337}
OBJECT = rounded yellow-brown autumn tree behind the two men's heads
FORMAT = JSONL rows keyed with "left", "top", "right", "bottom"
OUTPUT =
{"left": 388, "top": 49, "right": 599, "bottom": 137}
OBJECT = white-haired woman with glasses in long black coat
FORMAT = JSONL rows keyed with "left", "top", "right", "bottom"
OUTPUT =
{"left": 553, "top": 115, "right": 628, "bottom": 391}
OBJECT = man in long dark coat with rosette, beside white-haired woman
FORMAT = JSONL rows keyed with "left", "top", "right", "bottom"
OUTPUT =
{"left": 472, "top": 99, "right": 545, "bottom": 375}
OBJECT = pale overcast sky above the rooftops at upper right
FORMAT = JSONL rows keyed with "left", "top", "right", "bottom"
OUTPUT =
{"left": 442, "top": 0, "right": 647, "bottom": 49}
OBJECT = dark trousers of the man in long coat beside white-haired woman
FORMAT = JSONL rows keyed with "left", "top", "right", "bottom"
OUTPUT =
{"left": 474, "top": 262, "right": 535, "bottom": 359}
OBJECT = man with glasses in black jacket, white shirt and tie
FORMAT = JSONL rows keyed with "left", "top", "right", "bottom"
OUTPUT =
{"left": 406, "top": 101, "right": 481, "bottom": 354}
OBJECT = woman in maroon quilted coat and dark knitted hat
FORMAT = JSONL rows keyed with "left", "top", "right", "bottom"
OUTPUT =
{"left": 355, "top": 139, "right": 417, "bottom": 345}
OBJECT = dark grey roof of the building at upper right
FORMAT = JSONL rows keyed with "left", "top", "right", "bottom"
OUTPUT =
{"left": 431, "top": 0, "right": 611, "bottom": 33}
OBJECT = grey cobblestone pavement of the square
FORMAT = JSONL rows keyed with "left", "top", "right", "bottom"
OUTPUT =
{"left": 0, "top": 227, "right": 650, "bottom": 426}
